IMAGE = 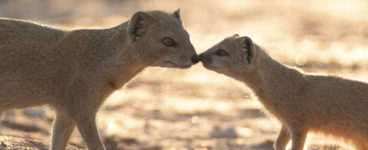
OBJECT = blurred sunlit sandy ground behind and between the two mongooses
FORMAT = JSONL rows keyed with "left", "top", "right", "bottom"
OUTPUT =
{"left": 0, "top": 0, "right": 368, "bottom": 150}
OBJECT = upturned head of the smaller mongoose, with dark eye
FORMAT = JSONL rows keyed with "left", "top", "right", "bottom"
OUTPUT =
{"left": 199, "top": 34, "right": 256, "bottom": 76}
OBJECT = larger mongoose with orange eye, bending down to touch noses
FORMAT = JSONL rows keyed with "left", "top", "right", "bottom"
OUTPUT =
{"left": 0, "top": 10, "right": 199, "bottom": 150}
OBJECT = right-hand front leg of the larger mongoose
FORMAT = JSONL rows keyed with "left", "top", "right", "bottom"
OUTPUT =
{"left": 75, "top": 113, "right": 105, "bottom": 150}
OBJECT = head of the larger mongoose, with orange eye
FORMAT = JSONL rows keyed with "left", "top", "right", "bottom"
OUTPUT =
{"left": 128, "top": 10, "right": 199, "bottom": 68}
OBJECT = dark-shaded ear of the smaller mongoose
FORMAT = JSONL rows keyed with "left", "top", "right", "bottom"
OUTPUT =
{"left": 238, "top": 36, "right": 255, "bottom": 64}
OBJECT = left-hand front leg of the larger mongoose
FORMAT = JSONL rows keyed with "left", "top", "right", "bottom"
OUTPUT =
{"left": 51, "top": 112, "right": 75, "bottom": 150}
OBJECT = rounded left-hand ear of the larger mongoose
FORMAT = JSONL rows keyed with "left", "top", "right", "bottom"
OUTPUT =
{"left": 128, "top": 11, "right": 158, "bottom": 42}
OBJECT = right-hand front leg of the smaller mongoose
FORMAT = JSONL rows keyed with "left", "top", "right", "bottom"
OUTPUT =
{"left": 291, "top": 129, "right": 307, "bottom": 150}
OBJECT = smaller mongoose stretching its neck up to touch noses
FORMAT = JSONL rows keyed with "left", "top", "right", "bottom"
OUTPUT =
{"left": 199, "top": 35, "right": 368, "bottom": 150}
